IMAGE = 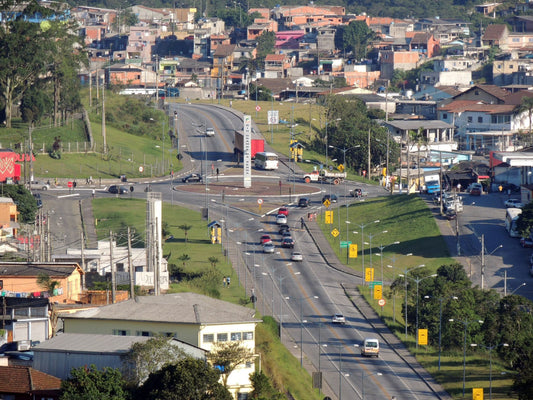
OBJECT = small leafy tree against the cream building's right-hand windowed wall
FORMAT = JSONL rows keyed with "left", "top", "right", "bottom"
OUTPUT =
{"left": 207, "top": 342, "right": 254, "bottom": 387}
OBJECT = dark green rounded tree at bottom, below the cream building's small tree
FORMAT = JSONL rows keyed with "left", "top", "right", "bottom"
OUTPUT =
{"left": 136, "top": 357, "right": 232, "bottom": 400}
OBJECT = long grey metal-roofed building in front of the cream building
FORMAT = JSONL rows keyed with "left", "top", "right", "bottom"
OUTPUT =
{"left": 32, "top": 333, "right": 207, "bottom": 379}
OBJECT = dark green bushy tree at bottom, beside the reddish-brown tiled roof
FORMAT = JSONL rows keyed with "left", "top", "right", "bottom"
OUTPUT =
{"left": 60, "top": 365, "right": 128, "bottom": 400}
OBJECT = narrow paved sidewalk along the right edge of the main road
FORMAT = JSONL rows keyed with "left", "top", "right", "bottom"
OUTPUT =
{"left": 305, "top": 221, "right": 451, "bottom": 399}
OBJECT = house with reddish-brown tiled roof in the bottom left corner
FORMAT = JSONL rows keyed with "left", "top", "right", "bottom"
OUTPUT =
{"left": 0, "top": 366, "right": 61, "bottom": 400}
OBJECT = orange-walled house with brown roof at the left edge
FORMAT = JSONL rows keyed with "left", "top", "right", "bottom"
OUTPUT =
{"left": 0, "top": 262, "right": 84, "bottom": 303}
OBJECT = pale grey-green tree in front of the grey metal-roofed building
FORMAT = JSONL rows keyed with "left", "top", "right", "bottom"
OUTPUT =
{"left": 122, "top": 337, "right": 185, "bottom": 386}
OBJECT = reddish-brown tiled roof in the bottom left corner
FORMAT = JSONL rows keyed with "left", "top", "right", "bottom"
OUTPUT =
{"left": 0, "top": 366, "right": 61, "bottom": 393}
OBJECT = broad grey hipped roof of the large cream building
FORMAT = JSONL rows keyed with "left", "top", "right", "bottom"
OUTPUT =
{"left": 64, "top": 293, "right": 260, "bottom": 325}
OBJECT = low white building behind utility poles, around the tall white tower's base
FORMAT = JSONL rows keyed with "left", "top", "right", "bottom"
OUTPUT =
{"left": 52, "top": 240, "right": 169, "bottom": 290}
